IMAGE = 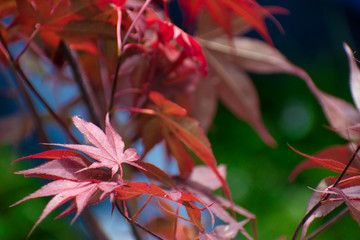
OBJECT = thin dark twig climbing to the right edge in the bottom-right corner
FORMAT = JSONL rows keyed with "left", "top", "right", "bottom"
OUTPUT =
{"left": 291, "top": 145, "right": 360, "bottom": 240}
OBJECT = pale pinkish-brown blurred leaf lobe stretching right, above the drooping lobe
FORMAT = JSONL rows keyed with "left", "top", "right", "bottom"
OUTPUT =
{"left": 199, "top": 37, "right": 296, "bottom": 74}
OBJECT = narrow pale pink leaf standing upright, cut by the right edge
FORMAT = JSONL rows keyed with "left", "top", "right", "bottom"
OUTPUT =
{"left": 344, "top": 43, "right": 360, "bottom": 109}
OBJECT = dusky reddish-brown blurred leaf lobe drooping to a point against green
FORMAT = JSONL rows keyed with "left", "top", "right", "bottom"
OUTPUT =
{"left": 206, "top": 49, "right": 276, "bottom": 146}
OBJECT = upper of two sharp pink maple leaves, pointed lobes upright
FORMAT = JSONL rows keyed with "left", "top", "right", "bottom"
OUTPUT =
{"left": 51, "top": 115, "right": 141, "bottom": 178}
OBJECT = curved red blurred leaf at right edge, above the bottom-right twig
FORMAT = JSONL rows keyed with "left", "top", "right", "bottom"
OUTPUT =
{"left": 289, "top": 145, "right": 360, "bottom": 181}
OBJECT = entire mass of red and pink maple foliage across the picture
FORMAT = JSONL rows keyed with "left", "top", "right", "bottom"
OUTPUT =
{"left": 0, "top": 0, "right": 352, "bottom": 240}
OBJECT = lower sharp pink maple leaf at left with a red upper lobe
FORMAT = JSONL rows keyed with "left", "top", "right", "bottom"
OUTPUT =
{"left": 11, "top": 150, "right": 122, "bottom": 236}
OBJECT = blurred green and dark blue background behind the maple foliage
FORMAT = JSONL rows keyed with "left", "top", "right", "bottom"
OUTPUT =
{"left": 0, "top": 0, "right": 360, "bottom": 240}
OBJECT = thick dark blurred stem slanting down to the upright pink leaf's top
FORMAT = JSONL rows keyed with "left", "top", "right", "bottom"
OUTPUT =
{"left": 60, "top": 40, "right": 101, "bottom": 126}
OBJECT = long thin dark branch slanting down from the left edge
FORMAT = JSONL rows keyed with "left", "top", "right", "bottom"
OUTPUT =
{"left": 0, "top": 33, "right": 79, "bottom": 143}
